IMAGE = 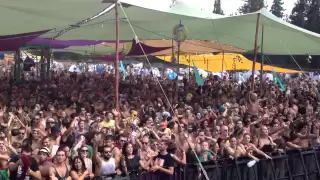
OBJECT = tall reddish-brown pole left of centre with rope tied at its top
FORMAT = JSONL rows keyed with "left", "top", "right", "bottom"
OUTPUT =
{"left": 115, "top": 0, "right": 120, "bottom": 112}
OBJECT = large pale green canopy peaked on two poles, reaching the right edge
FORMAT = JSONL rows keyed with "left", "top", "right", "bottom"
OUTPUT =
{"left": 43, "top": 0, "right": 320, "bottom": 55}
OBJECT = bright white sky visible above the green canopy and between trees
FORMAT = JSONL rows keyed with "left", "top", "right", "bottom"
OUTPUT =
{"left": 125, "top": 0, "right": 296, "bottom": 15}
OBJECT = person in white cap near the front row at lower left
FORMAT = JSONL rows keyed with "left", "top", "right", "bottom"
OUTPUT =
{"left": 38, "top": 147, "right": 53, "bottom": 179}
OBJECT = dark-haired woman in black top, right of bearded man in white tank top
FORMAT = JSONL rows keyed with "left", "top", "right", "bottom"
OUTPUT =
{"left": 121, "top": 143, "right": 144, "bottom": 180}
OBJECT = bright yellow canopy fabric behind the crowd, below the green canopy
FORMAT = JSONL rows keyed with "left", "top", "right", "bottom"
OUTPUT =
{"left": 156, "top": 53, "right": 301, "bottom": 73}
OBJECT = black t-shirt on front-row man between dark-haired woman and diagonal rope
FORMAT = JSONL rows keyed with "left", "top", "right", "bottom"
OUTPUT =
{"left": 155, "top": 153, "right": 174, "bottom": 179}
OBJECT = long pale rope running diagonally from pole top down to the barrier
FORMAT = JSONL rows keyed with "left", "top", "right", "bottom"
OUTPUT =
{"left": 118, "top": 1, "right": 210, "bottom": 180}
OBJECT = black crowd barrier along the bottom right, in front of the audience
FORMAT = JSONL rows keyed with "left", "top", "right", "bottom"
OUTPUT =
{"left": 95, "top": 148, "right": 320, "bottom": 180}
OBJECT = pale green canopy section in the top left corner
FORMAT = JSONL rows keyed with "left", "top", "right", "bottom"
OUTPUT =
{"left": 0, "top": 0, "right": 110, "bottom": 35}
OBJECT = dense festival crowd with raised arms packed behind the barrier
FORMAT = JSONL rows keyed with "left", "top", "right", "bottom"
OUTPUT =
{"left": 0, "top": 70, "right": 320, "bottom": 180}
